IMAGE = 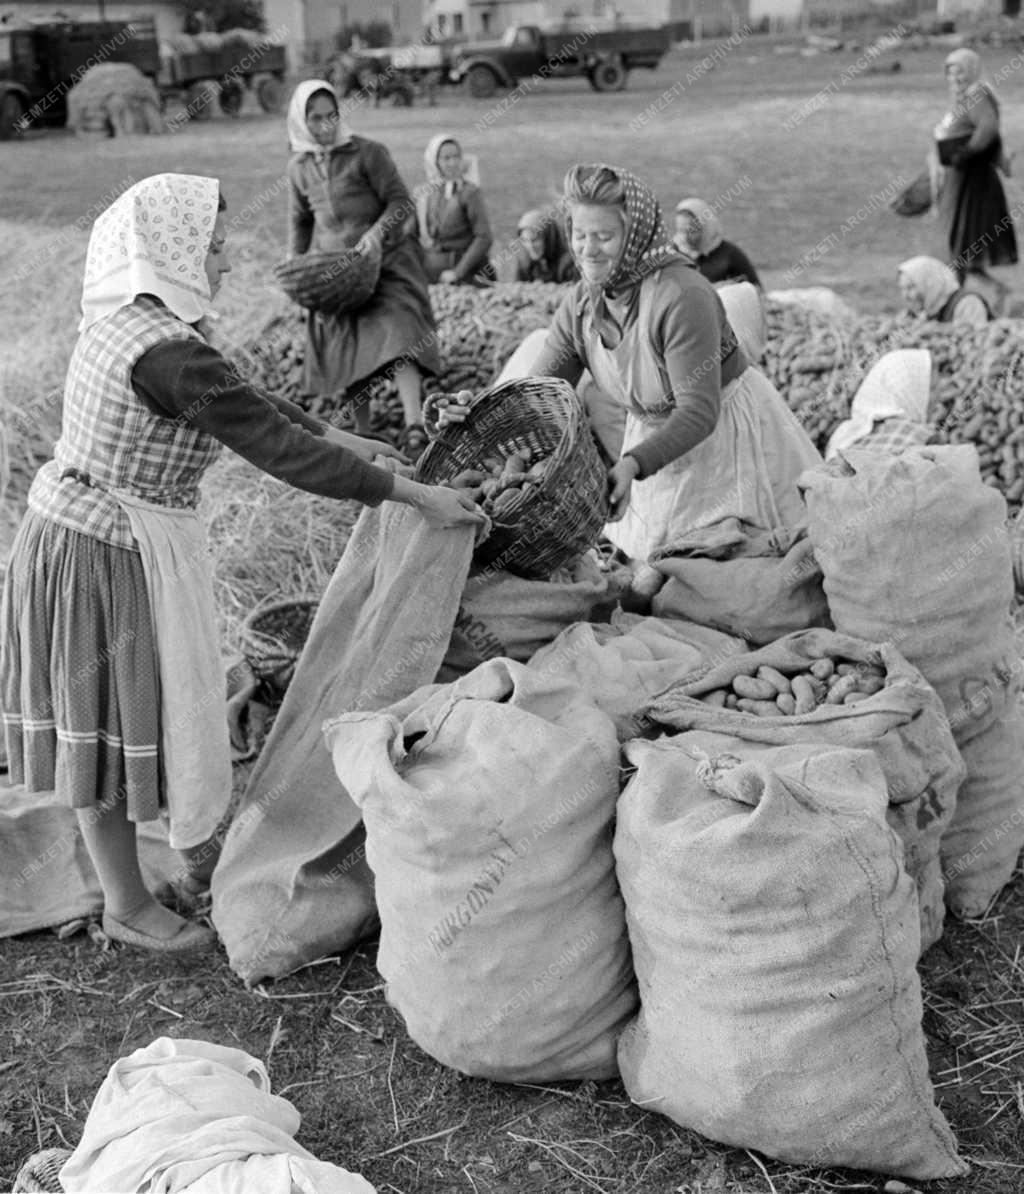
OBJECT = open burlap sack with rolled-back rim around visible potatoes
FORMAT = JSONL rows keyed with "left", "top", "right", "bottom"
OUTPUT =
{"left": 646, "top": 630, "right": 966, "bottom": 950}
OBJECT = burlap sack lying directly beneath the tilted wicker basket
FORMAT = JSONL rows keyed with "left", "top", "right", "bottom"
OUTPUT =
{"left": 437, "top": 553, "right": 628, "bottom": 684}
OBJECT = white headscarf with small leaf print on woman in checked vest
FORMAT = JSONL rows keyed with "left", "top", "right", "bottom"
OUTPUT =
{"left": 79, "top": 174, "right": 220, "bottom": 332}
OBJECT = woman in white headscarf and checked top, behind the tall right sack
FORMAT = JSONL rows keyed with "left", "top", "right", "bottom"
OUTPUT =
{"left": 825, "top": 349, "right": 932, "bottom": 460}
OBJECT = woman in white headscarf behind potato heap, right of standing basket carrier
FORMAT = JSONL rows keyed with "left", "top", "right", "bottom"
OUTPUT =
{"left": 417, "top": 133, "right": 494, "bottom": 287}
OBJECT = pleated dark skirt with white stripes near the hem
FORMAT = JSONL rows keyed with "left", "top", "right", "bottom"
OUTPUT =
{"left": 0, "top": 510, "right": 160, "bottom": 821}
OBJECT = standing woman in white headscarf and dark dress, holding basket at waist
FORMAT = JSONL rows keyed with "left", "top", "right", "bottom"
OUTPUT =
{"left": 288, "top": 79, "right": 440, "bottom": 456}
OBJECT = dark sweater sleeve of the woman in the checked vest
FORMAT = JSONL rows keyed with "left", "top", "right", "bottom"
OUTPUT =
{"left": 131, "top": 339, "right": 394, "bottom": 506}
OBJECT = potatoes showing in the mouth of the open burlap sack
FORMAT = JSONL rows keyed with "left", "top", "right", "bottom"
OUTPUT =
{"left": 698, "top": 659, "right": 886, "bottom": 718}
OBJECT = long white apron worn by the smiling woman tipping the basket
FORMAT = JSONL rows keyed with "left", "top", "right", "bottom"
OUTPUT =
{"left": 586, "top": 273, "right": 821, "bottom": 561}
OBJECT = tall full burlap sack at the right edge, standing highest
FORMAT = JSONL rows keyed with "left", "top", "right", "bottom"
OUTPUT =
{"left": 801, "top": 444, "right": 1024, "bottom": 916}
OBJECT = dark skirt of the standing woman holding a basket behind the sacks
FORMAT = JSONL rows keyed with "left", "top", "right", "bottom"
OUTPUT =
{"left": 297, "top": 239, "right": 440, "bottom": 395}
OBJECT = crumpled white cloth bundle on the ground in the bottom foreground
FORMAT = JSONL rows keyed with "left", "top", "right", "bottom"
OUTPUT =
{"left": 61, "top": 1036, "right": 375, "bottom": 1194}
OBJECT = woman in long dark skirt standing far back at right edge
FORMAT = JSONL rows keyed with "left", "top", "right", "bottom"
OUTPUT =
{"left": 936, "top": 48, "right": 1017, "bottom": 283}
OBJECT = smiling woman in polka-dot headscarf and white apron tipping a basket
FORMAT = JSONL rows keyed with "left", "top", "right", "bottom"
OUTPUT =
{"left": 438, "top": 164, "right": 821, "bottom": 561}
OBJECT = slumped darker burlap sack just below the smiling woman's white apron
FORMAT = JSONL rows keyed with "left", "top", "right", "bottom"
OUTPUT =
{"left": 650, "top": 518, "right": 832, "bottom": 646}
